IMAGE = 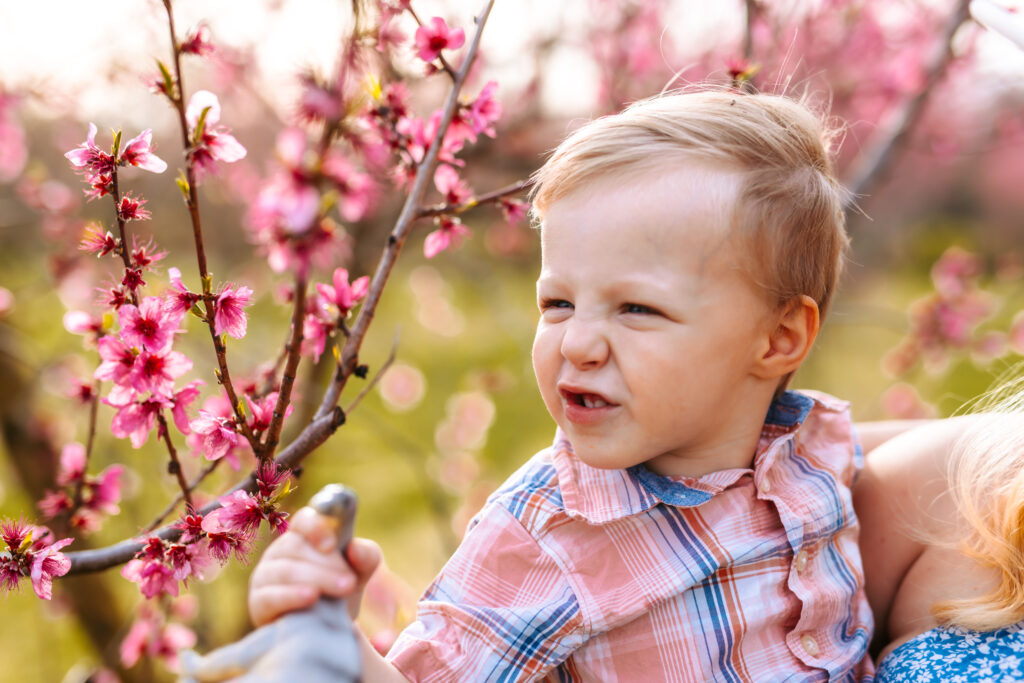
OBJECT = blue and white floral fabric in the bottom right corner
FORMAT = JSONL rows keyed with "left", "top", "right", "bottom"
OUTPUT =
{"left": 874, "top": 622, "right": 1024, "bottom": 683}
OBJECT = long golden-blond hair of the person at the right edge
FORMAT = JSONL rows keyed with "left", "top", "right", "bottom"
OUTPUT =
{"left": 933, "top": 365, "right": 1024, "bottom": 631}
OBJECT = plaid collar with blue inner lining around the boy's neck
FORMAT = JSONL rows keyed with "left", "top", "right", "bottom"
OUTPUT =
{"left": 552, "top": 391, "right": 816, "bottom": 524}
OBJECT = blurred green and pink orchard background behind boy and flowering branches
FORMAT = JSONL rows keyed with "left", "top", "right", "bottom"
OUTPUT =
{"left": 0, "top": 0, "right": 1024, "bottom": 681}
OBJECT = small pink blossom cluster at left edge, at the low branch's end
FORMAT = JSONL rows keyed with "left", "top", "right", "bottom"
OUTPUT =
{"left": 0, "top": 519, "right": 73, "bottom": 600}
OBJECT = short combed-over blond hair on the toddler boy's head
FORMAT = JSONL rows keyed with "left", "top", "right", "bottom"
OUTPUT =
{"left": 532, "top": 89, "right": 848, "bottom": 316}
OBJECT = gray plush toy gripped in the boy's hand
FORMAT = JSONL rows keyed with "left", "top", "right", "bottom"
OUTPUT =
{"left": 180, "top": 484, "right": 362, "bottom": 683}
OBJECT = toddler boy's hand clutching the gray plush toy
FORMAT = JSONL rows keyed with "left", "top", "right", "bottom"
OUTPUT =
{"left": 249, "top": 507, "right": 381, "bottom": 626}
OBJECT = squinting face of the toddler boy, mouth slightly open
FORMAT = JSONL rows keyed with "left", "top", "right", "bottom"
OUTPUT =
{"left": 534, "top": 166, "right": 771, "bottom": 476}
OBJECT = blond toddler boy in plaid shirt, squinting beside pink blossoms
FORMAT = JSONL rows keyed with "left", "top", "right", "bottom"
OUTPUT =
{"left": 250, "top": 91, "right": 871, "bottom": 681}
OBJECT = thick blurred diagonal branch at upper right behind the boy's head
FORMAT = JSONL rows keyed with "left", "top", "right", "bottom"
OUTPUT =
{"left": 844, "top": 0, "right": 970, "bottom": 209}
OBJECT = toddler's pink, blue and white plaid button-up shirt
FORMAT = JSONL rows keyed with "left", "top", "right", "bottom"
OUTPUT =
{"left": 388, "top": 391, "right": 872, "bottom": 682}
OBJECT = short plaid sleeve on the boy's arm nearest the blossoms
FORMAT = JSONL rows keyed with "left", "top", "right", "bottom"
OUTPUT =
{"left": 388, "top": 504, "right": 586, "bottom": 681}
